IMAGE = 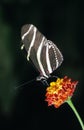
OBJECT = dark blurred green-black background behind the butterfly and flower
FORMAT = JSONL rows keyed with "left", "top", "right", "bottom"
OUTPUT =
{"left": 0, "top": 0, "right": 84, "bottom": 130}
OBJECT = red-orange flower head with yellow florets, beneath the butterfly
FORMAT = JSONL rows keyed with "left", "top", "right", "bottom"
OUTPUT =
{"left": 45, "top": 76, "right": 78, "bottom": 108}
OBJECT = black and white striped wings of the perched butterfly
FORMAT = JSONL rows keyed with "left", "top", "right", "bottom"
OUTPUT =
{"left": 21, "top": 24, "right": 63, "bottom": 78}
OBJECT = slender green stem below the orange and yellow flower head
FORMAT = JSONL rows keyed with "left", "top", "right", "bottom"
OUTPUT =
{"left": 67, "top": 99, "right": 84, "bottom": 130}
